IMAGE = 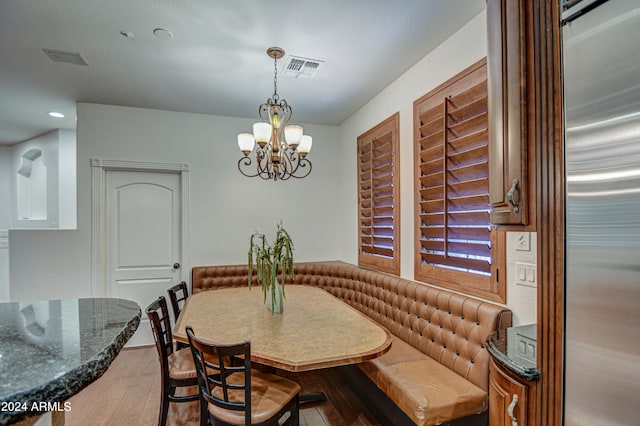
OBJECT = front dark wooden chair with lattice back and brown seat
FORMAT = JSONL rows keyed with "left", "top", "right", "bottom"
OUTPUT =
{"left": 186, "top": 326, "right": 300, "bottom": 426}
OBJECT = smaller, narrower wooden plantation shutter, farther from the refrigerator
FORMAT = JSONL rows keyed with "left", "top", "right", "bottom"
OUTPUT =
{"left": 358, "top": 113, "right": 400, "bottom": 274}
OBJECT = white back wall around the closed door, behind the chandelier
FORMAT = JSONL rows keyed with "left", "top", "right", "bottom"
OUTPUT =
{"left": 10, "top": 104, "right": 347, "bottom": 300}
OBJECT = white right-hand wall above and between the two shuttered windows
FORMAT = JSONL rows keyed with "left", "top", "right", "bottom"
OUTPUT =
{"left": 340, "top": 12, "right": 487, "bottom": 279}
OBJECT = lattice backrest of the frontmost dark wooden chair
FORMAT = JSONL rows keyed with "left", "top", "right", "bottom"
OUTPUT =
{"left": 186, "top": 325, "right": 251, "bottom": 425}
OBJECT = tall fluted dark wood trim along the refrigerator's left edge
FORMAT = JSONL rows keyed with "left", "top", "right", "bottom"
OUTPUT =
{"left": 525, "top": 0, "right": 564, "bottom": 425}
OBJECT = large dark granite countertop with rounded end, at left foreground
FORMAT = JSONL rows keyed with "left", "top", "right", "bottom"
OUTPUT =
{"left": 0, "top": 298, "right": 141, "bottom": 425}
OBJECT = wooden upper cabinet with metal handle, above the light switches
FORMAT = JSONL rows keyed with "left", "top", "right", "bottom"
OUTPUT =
{"left": 487, "top": 0, "right": 532, "bottom": 225}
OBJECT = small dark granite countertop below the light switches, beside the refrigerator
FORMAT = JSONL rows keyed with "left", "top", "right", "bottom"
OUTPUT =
{"left": 487, "top": 324, "right": 540, "bottom": 380}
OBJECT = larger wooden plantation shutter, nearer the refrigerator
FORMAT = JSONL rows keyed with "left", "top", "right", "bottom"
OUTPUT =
{"left": 414, "top": 60, "right": 493, "bottom": 291}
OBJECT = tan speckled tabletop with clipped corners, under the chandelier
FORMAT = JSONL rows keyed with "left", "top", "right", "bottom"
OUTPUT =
{"left": 173, "top": 285, "right": 391, "bottom": 371}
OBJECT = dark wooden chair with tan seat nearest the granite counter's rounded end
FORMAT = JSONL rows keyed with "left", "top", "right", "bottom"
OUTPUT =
{"left": 146, "top": 296, "right": 199, "bottom": 426}
